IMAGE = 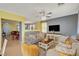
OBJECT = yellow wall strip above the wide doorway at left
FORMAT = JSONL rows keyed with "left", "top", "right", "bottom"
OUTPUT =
{"left": 0, "top": 11, "right": 26, "bottom": 22}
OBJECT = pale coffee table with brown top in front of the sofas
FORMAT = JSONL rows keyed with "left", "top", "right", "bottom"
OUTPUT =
{"left": 38, "top": 39, "right": 54, "bottom": 50}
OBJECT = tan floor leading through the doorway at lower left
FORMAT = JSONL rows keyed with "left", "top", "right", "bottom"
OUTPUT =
{"left": 5, "top": 39, "right": 22, "bottom": 56}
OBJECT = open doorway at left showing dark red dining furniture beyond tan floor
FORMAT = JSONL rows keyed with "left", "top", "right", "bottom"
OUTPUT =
{"left": 2, "top": 19, "right": 22, "bottom": 56}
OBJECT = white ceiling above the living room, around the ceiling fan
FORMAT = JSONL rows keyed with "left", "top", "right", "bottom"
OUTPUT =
{"left": 0, "top": 3, "right": 79, "bottom": 22}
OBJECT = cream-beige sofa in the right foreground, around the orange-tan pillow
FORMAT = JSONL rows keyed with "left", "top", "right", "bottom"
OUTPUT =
{"left": 46, "top": 34, "right": 79, "bottom": 56}
